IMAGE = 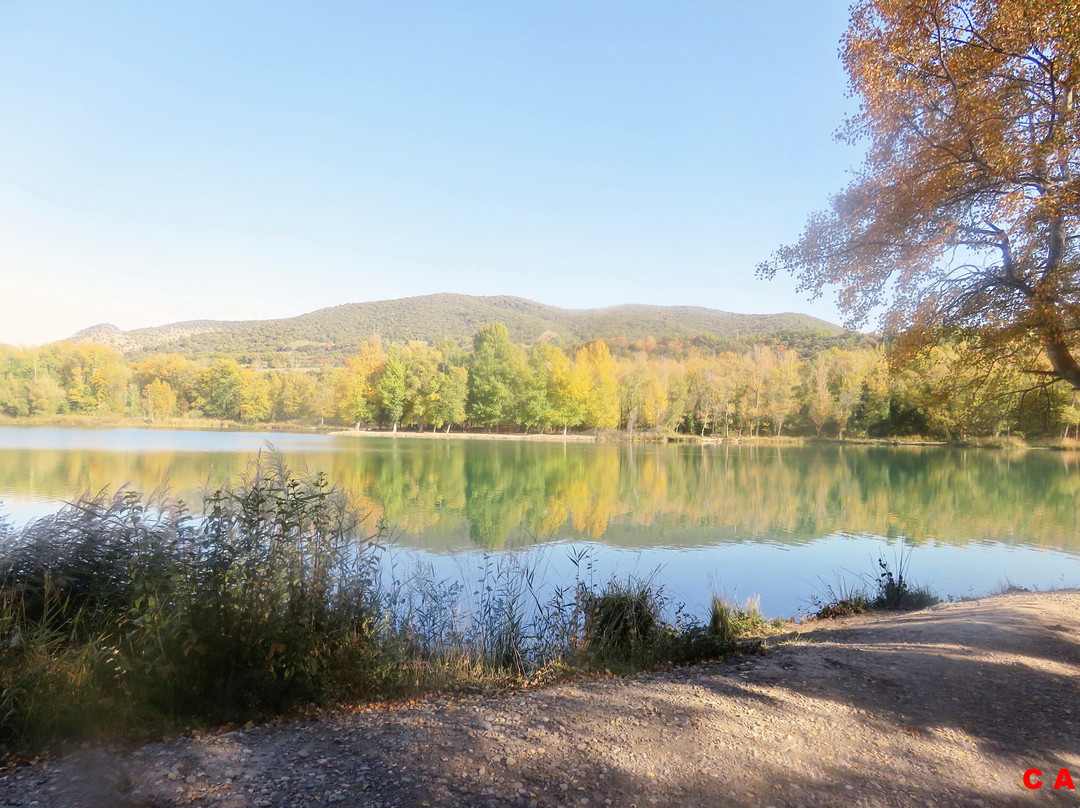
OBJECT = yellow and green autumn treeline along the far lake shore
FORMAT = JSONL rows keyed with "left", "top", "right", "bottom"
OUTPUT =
{"left": 0, "top": 324, "right": 1080, "bottom": 440}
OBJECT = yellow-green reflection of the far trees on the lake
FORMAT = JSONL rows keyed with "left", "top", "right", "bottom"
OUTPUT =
{"left": 0, "top": 428, "right": 1080, "bottom": 554}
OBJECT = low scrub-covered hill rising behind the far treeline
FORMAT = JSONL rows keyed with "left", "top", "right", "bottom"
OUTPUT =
{"left": 71, "top": 294, "right": 845, "bottom": 356}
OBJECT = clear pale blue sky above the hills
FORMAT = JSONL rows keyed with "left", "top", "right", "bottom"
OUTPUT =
{"left": 0, "top": 0, "right": 861, "bottom": 345}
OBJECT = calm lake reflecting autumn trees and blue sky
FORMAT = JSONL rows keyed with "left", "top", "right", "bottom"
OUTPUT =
{"left": 0, "top": 427, "right": 1080, "bottom": 616}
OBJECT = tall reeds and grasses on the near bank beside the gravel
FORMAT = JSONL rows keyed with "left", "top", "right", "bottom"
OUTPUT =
{"left": 0, "top": 455, "right": 766, "bottom": 754}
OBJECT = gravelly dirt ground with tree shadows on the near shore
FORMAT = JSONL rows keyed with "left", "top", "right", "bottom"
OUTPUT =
{"left": 0, "top": 591, "right": 1080, "bottom": 808}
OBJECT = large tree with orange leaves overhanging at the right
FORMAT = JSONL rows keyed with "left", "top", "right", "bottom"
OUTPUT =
{"left": 758, "top": 0, "right": 1080, "bottom": 388}
